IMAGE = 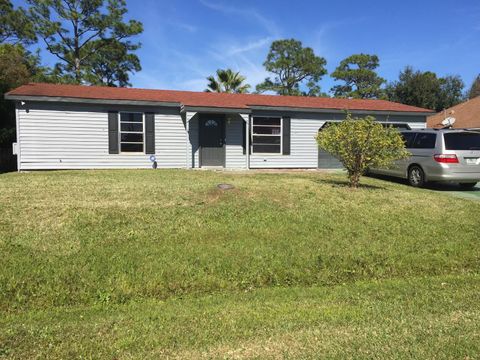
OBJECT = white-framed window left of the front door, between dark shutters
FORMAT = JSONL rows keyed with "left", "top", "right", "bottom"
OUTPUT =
{"left": 119, "top": 112, "right": 144, "bottom": 153}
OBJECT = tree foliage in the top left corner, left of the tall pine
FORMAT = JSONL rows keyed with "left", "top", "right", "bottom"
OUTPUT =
{"left": 0, "top": 0, "right": 36, "bottom": 45}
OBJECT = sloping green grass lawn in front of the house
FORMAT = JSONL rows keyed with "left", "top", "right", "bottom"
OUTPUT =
{"left": 0, "top": 170, "right": 480, "bottom": 359}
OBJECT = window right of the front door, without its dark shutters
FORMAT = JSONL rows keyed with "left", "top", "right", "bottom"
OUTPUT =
{"left": 252, "top": 117, "right": 282, "bottom": 154}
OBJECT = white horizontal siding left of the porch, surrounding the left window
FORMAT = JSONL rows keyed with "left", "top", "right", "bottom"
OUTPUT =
{"left": 18, "top": 104, "right": 186, "bottom": 170}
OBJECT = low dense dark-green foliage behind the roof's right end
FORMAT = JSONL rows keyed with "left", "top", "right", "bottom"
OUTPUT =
{"left": 386, "top": 66, "right": 464, "bottom": 112}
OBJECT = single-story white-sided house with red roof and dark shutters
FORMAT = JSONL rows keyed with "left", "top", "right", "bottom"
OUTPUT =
{"left": 5, "top": 84, "right": 431, "bottom": 170}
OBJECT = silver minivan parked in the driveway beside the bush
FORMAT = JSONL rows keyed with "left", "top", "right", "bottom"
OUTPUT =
{"left": 369, "top": 129, "right": 480, "bottom": 188}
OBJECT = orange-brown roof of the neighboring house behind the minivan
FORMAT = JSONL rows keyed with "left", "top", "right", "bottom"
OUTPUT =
{"left": 427, "top": 96, "right": 480, "bottom": 129}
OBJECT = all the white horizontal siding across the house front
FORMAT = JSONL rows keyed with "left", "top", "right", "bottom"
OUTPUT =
{"left": 17, "top": 102, "right": 425, "bottom": 170}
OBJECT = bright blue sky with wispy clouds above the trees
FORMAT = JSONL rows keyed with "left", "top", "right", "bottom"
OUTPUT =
{"left": 14, "top": 0, "right": 480, "bottom": 91}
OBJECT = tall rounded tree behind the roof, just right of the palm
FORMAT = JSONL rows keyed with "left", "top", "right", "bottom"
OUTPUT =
{"left": 256, "top": 39, "right": 327, "bottom": 95}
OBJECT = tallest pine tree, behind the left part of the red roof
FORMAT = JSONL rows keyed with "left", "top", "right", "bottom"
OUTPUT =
{"left": 28, "top": 0, "right": 143, "bottom": 83}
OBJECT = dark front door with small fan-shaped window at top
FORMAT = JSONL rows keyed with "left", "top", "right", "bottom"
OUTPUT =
{"left": 199, "top": 114, "right": 225, "bottom": 167}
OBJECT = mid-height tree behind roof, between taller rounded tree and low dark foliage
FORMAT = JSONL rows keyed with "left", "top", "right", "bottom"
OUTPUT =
{"left": 331, "top": 54, "right": 385, "bottom": 99}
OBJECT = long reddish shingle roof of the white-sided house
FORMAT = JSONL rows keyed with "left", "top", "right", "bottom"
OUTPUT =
{"left": 6, "top": 83, "right": 432, "bottom": 113}
